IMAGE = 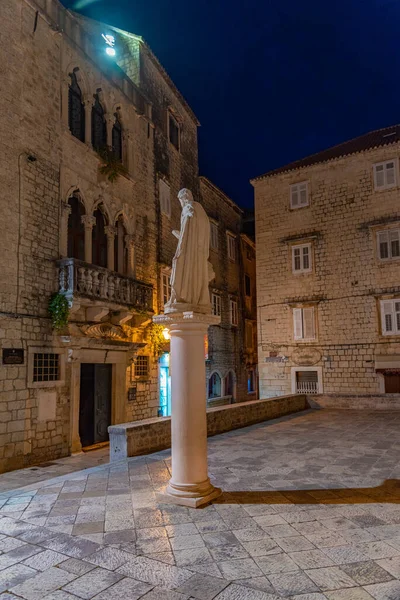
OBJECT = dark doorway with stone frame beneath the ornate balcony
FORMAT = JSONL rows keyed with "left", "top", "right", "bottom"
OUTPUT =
{"left": 79, "top": 363, "right": 112, "bottom": 448}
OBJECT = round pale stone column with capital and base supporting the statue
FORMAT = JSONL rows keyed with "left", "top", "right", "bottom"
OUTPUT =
{"left": 153, "top": 311, "right": 221, "bottom": 508}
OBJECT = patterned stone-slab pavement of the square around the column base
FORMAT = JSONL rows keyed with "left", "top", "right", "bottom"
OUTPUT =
{"left": 0, "top": 410, "right": 400, "bottom": 600}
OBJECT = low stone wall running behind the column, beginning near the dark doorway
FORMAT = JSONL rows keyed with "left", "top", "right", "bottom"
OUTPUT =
{"left": 108, "top": 394, "right": 308, "bottom": 461}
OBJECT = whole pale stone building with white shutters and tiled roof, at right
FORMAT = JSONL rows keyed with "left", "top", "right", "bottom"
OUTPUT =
{"left": 252, "top": 126, "right": 400, "bottom": 399}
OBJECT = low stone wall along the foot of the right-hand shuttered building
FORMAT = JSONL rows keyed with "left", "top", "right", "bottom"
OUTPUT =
{"left": 307, "top": 394, "right": 400, "bottom": 410}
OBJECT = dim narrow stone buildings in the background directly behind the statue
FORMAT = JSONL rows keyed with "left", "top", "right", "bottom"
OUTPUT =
{"left": 200, "top": 177, "right": 257, "bottom": 405}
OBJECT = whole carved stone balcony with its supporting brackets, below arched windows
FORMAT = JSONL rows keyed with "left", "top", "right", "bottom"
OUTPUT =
{"left": 57, "top": 258, "right": 153, "bottom": 321}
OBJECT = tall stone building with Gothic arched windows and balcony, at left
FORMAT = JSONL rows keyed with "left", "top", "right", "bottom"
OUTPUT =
{"left": 0, "top": 0, "right": 198, "bottom": 471}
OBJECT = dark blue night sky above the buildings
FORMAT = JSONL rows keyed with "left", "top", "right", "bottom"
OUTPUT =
{"left": 63, "top": 0, "right": 400, "bottom": 208}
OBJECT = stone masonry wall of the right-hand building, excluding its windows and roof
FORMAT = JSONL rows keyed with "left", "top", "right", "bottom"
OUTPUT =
{"left": 254, "top": 144, "right": 400, "bottom": 397}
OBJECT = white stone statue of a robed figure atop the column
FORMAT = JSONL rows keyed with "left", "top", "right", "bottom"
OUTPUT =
{"left": 164, "top": 188, "right": 215, "bottom": 314}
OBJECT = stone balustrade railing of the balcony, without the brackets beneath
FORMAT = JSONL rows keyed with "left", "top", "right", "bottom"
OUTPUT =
{"left": 57, "top": 258, "right": 153, "bottom": 311}
